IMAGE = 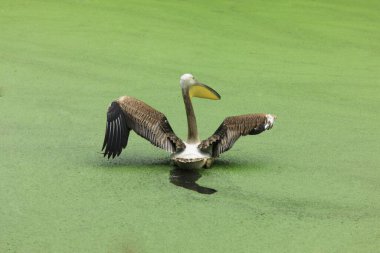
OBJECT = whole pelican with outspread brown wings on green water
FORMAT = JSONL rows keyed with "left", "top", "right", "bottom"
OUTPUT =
{"left": 102, "top": 74, "right": 276, "bottom": 169}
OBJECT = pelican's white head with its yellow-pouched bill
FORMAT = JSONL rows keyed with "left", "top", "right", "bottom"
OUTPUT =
{"left": 180, "top": 74, "right": 220, "bottom": 100}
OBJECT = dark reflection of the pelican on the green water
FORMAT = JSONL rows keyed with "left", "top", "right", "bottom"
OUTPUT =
{"left": 170, "top": 168, "right": 217, "bottom": 194}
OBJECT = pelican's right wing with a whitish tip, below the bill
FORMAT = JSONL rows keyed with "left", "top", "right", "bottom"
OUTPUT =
{"left": 198, "top": 114, "right": 276, "bottom": 157}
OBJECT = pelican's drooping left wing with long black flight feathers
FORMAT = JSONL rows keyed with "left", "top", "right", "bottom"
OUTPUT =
{"left": 102, "top": 96, "right": 185, "bottom": 158}
